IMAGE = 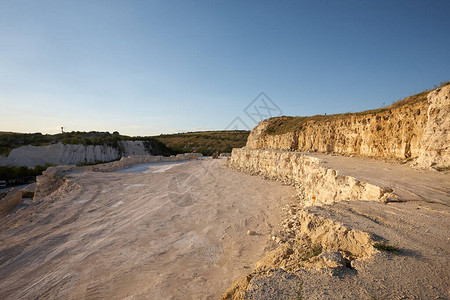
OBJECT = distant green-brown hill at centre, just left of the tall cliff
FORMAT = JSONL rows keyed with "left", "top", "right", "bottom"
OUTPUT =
{"left": 152, "top": 130, "right": 250, "bottom": 155}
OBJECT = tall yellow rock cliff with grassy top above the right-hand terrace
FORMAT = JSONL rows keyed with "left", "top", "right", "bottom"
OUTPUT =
{"left": 246, "top": 85, "right": 450, "bottom": 167}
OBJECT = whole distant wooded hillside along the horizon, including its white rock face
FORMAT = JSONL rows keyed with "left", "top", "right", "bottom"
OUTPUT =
{"left": 0, "top": 131, "right": 249, "bottom": 184}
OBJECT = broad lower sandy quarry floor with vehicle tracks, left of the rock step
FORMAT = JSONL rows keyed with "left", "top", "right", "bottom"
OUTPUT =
{"left": 0, "top": 159, "right": 295, "bottom": 299}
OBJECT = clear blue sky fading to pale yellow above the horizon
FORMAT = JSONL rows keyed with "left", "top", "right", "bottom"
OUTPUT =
{"left": 0, "top": 0, "right": 450, "bottom": 135}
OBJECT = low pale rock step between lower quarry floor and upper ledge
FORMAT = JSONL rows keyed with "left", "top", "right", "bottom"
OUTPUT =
{"left": 228, "top": 148, "right": 392, "bottom": 205}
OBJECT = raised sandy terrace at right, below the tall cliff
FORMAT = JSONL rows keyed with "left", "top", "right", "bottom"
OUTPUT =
{"left": 243, "top": 153, "right": 450, "bottom": 299}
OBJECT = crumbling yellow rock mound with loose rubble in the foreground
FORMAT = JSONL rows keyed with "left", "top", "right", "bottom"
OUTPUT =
{"left": 221, "top": 205, "right": 377, "bottom": 299}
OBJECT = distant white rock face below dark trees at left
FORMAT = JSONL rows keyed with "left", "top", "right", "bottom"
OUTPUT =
{"left": 0, "top": 141, "right": 167, "bottom": 167}
